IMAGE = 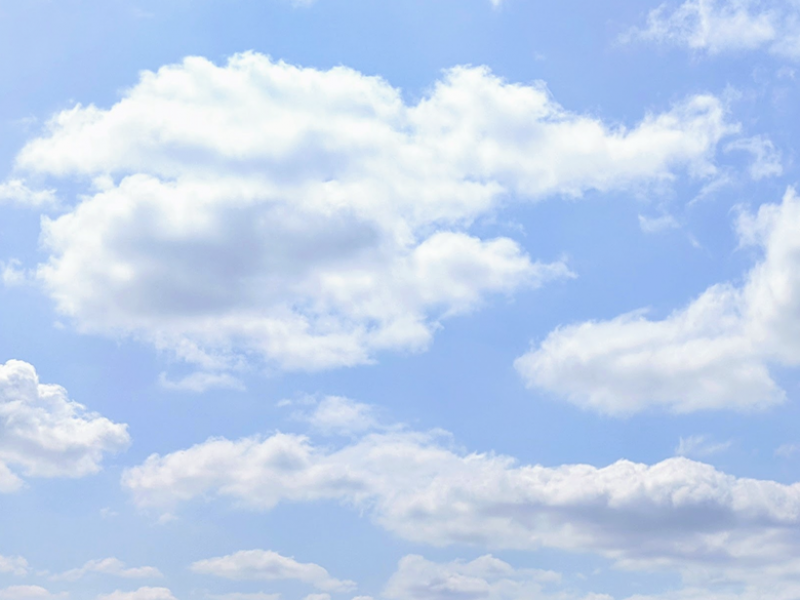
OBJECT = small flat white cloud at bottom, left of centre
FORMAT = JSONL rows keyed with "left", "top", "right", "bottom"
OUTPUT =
{"left": 191, "top": 550, "right": 356, "bottom": 592}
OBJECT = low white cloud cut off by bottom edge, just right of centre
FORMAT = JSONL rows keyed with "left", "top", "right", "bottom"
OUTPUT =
{"left": 382, "top": 555, "right": 560, "bottom": 600}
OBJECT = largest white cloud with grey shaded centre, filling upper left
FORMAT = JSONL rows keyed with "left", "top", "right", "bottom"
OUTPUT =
{"left": 10, "top": 53, "right": 736, "bottom": 376}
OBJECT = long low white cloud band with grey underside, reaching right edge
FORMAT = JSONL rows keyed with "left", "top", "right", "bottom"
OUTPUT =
{"left": 123, "top": 418, "right": 800, "bottom": 594}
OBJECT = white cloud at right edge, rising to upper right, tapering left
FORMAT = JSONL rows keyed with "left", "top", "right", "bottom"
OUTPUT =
{"left": 515, "top": 189, "right": 800, "bottom": 415}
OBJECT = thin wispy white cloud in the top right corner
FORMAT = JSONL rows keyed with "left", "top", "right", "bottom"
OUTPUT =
{"left": 626, "top": 0, "right": 800, "bottom": 60}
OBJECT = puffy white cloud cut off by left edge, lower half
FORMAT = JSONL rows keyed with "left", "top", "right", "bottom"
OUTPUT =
{"left": 0, "top": 360, "right": 130, "bottom": 492}
